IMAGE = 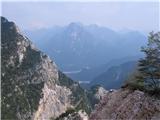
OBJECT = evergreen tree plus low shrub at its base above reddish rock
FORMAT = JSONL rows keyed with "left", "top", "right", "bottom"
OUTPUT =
{"left": 125, "top": 32, "right": 160, "bottom": 95}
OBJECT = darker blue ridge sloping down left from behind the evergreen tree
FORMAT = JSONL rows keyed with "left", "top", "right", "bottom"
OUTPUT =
{"left": 89, "top": 61, "right": 138, "bottom": 89}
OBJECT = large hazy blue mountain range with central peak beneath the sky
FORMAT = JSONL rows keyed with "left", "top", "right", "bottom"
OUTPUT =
{"left": 25, "top": 23, "right": 146, "bottom": 72}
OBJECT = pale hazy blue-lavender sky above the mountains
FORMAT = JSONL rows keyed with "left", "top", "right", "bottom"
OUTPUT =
{"left": 2, "top": 2, "right": 160, "bottom": 32}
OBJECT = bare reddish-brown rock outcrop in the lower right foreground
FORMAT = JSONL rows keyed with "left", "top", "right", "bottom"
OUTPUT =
{"left": 90, "top": 89, "right": 160, "bottom": 120}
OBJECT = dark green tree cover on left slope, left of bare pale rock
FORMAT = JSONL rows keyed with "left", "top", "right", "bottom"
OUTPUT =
{"left": 1, "top": 18, "right": 44, "bottom": 120}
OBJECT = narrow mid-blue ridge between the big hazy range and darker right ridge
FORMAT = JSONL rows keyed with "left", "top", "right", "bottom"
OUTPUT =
{"left": 66, "top": 56, "right": 141, "bottom": 84}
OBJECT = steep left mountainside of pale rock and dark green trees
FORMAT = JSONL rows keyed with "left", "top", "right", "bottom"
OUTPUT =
{"left": 1, "top": 17, "right": 90, "bottom": 120}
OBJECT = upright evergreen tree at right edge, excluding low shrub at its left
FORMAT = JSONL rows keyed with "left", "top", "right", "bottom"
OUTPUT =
{"left": 137, "top": 32, "right": 160, "bottom": 94}
